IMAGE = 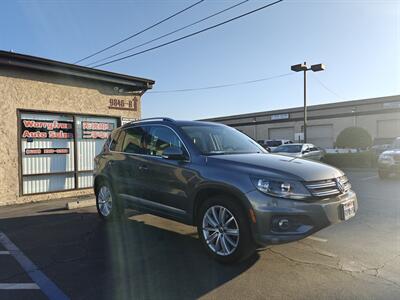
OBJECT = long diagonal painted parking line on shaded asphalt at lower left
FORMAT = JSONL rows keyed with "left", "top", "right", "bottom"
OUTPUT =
{"left": 0, "top": 232, "right": 69, "bottom": 300}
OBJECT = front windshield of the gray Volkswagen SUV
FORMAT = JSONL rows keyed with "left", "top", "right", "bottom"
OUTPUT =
{"left": 181, "top": 125, "right": 264, "bottom": 155}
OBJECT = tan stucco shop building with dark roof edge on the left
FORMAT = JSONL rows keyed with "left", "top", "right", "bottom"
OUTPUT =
{"left": 0, "top": 51, "right": 154, "bottom": 206}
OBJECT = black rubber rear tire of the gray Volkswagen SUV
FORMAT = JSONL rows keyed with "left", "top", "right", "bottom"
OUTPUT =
{"left": 96, "top": 180, "right": 125, "bottom": 222}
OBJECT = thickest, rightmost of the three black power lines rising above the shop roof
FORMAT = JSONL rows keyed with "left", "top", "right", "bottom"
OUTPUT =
{"left": 93, "top": 0, "right": 283, "bottom": 68}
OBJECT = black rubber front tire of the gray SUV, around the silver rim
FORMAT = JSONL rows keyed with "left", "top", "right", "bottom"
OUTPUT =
{"left": 197, "top": 195, "right": 256, "bottom": 264}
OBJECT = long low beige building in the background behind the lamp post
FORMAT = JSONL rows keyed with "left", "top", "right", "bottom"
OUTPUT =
{"left": 203, "top": 96, "right": 400, "bottom": 148}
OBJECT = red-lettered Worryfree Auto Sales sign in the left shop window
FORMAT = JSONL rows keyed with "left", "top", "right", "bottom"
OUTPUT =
{"left": 21, "top": 119, "right": 74, "bottom": 139}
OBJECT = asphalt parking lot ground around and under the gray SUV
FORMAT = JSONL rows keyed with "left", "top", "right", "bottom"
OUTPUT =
{"left": 0, "top": 171, "right": 400, "bottom": 299}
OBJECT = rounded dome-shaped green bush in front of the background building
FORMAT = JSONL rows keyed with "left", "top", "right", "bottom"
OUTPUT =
{"left": 336, "top": 127, "right": 372, "bottom": 149}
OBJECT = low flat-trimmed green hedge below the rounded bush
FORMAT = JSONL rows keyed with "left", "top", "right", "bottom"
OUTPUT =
{"left": 322, "top": 151, "right": 376, "bottom": 168}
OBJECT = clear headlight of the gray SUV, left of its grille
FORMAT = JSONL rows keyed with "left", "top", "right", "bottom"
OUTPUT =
{"left": 253, "top": 178, "right": 311, "bottom": 200}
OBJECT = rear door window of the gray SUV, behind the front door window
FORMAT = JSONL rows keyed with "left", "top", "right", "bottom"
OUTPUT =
{"left": 122, "top": 126, "right": 150, "bottom": 155}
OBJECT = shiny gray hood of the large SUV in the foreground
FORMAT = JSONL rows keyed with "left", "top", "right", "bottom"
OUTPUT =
{"left": 208, "top": 153, "right": 344, "bottom": 181}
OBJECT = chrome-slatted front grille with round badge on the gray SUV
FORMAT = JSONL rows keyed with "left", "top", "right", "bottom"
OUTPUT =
{"left": 305, "top": 175, "right": 351, "bottom": 197}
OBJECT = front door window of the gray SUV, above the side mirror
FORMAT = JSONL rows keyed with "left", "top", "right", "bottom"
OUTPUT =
{"left": 148, "top": 125, "right": 187, "bottom": 156}
